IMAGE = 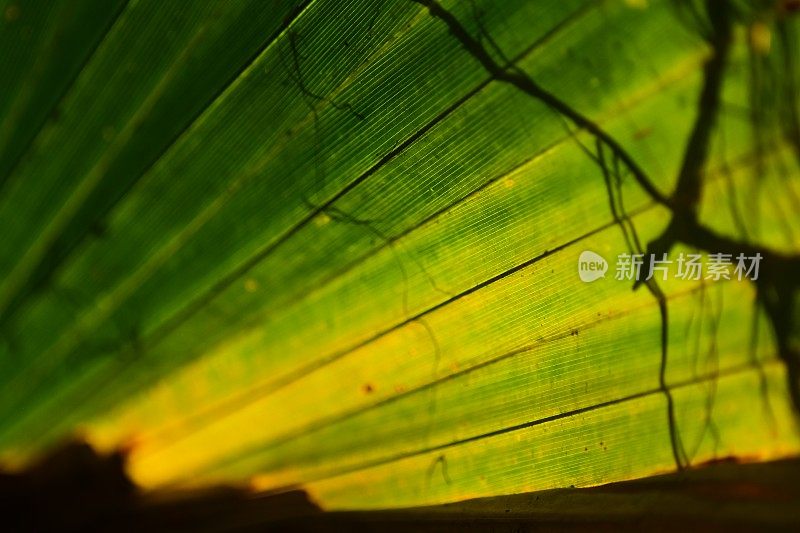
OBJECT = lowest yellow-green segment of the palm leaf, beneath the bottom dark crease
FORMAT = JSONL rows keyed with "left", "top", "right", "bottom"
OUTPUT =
{"left": 304, "top": 364, "right": 800, "bottom": 509}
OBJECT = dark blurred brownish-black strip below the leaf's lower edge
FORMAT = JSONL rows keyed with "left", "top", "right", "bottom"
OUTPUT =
{"left": 0, "top": 443, "right": 800, "bottom": 532}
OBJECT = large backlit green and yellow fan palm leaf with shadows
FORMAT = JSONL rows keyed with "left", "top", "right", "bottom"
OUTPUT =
{"left": 0, "top": 0, "right": 800, "bottom": 508}
